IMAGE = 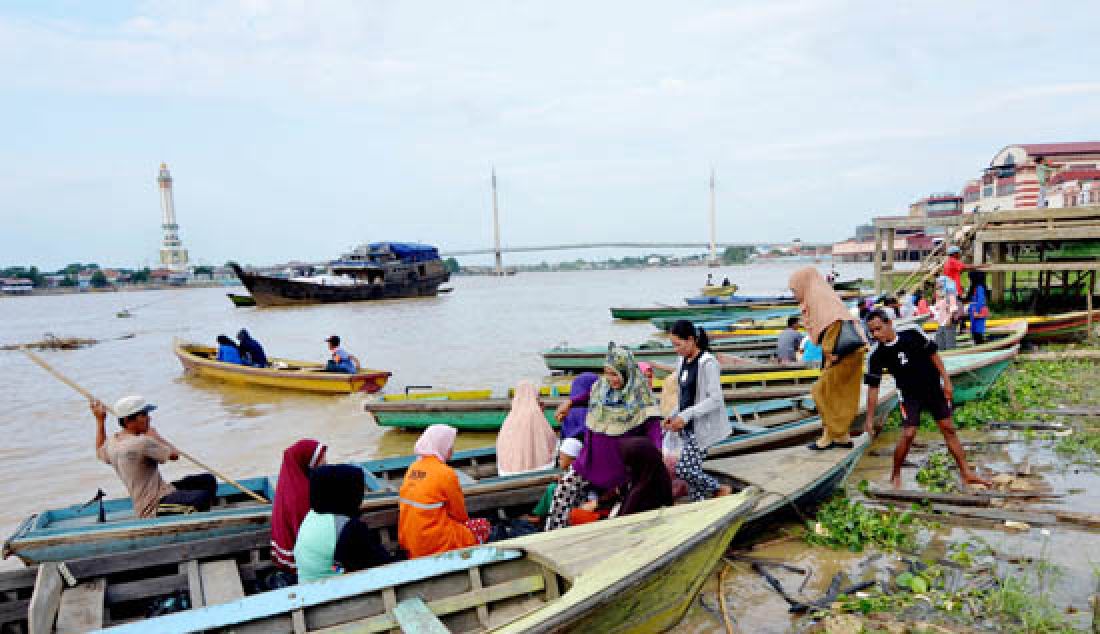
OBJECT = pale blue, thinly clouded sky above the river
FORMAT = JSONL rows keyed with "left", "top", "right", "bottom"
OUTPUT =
{"left": 0, "top": 0, "right": 1100, "bottom": 269}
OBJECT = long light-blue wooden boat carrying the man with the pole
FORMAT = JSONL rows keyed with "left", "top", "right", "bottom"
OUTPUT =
{"left": 3, "top": 380, "right": 898, "bottom": 564}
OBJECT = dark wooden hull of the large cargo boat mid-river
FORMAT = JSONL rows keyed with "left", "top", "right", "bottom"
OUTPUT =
{"left": 232, "top": 258, "right": 450, "bottom": 306}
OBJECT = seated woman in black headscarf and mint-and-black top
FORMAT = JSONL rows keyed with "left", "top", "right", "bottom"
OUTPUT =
{"left": 294, "top": 464, "right": 393, "bottom": 583}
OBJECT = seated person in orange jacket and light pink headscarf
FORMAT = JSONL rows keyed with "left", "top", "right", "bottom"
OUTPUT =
{"left": 397, "top": 425, "right": 491, "bottom": 558}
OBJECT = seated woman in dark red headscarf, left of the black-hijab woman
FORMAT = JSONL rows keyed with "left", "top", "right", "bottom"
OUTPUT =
{"left": 272, "top": 438, "right": 327, "bottom": 573}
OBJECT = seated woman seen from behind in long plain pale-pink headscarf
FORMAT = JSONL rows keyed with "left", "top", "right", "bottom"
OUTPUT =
{"left": 496, "top": 381, "right": 558, "bottom": 476}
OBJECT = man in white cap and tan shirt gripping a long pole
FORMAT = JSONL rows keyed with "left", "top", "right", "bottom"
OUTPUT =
{"left": 91, "top": 396, "right": 218, "bottom": 518}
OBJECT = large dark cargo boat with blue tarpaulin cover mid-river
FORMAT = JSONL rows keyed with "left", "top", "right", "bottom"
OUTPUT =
{"left": 230, "top": 242, "right": 450, "bottom": 306}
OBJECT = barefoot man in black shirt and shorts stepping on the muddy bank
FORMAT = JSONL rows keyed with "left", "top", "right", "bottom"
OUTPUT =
{"left": 865, "top": 310, "right": 990, "bottom": 489}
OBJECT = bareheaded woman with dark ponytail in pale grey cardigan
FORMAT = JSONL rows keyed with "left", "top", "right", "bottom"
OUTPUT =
{"left": 662, "top": 319, "right": 732, "bottom": 502}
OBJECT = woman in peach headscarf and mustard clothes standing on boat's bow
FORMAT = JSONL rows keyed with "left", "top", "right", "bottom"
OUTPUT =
{"left": 790, "top": 266, "right": 867, "bottom": 450}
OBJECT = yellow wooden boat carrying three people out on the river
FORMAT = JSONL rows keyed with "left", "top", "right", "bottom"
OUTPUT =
{"left": 174, "top": 341, "right": 391, "bottom": 394}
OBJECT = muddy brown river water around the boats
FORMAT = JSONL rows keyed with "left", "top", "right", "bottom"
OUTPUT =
{"left": 0, "top": 263, "right": 869, "bottom": 565}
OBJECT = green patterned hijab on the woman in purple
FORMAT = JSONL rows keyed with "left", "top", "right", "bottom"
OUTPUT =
{"left": 585, "top": 343, "right": 661, "bottom": 436}
